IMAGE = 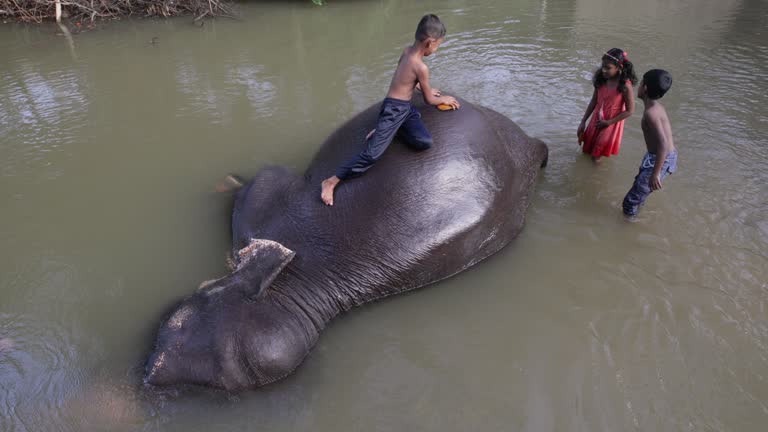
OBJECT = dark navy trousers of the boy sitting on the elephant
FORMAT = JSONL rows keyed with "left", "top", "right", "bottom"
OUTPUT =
{"left": 336, "top": 98, "right": 432, "bottom": 180}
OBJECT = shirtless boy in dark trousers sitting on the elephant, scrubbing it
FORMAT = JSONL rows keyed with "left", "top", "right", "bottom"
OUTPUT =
{"left": 320, "top": 15, "right": 459, "bottom": 205}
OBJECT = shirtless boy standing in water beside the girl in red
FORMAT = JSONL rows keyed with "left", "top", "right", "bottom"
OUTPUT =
{"left": 622, "top": 69, "right": 677, "bottom": 217}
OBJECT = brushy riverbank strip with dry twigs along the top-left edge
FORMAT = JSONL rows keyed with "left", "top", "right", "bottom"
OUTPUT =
{"left": 0, "top": 0, "right": 234, "bottom": 23}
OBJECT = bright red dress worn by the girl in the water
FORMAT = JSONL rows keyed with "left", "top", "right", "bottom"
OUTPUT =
{"left": 583, "top": 81, "right": 632, "bottom": 157}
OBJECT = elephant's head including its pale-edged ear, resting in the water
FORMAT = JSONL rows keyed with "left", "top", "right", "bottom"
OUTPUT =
{"left": 144, "top": 240, "right": 309, "bottom": 391}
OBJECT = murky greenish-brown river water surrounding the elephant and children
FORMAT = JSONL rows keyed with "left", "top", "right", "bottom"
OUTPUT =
{"left": 0, "top": 0, "right": 768, "bottom": 432}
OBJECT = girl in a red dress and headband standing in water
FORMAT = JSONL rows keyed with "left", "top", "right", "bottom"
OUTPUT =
{"left": 576, "top": 48, "right": 637, "bottom": 162}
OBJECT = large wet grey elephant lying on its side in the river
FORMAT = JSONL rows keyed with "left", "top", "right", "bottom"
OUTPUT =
{"left": 145, "top": 97, "right": 547, "bottom": 392}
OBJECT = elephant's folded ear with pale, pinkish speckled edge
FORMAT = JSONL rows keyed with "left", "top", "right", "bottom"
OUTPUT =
{"left": 234, "top": 239, "right": 296, "bottom": 298}
